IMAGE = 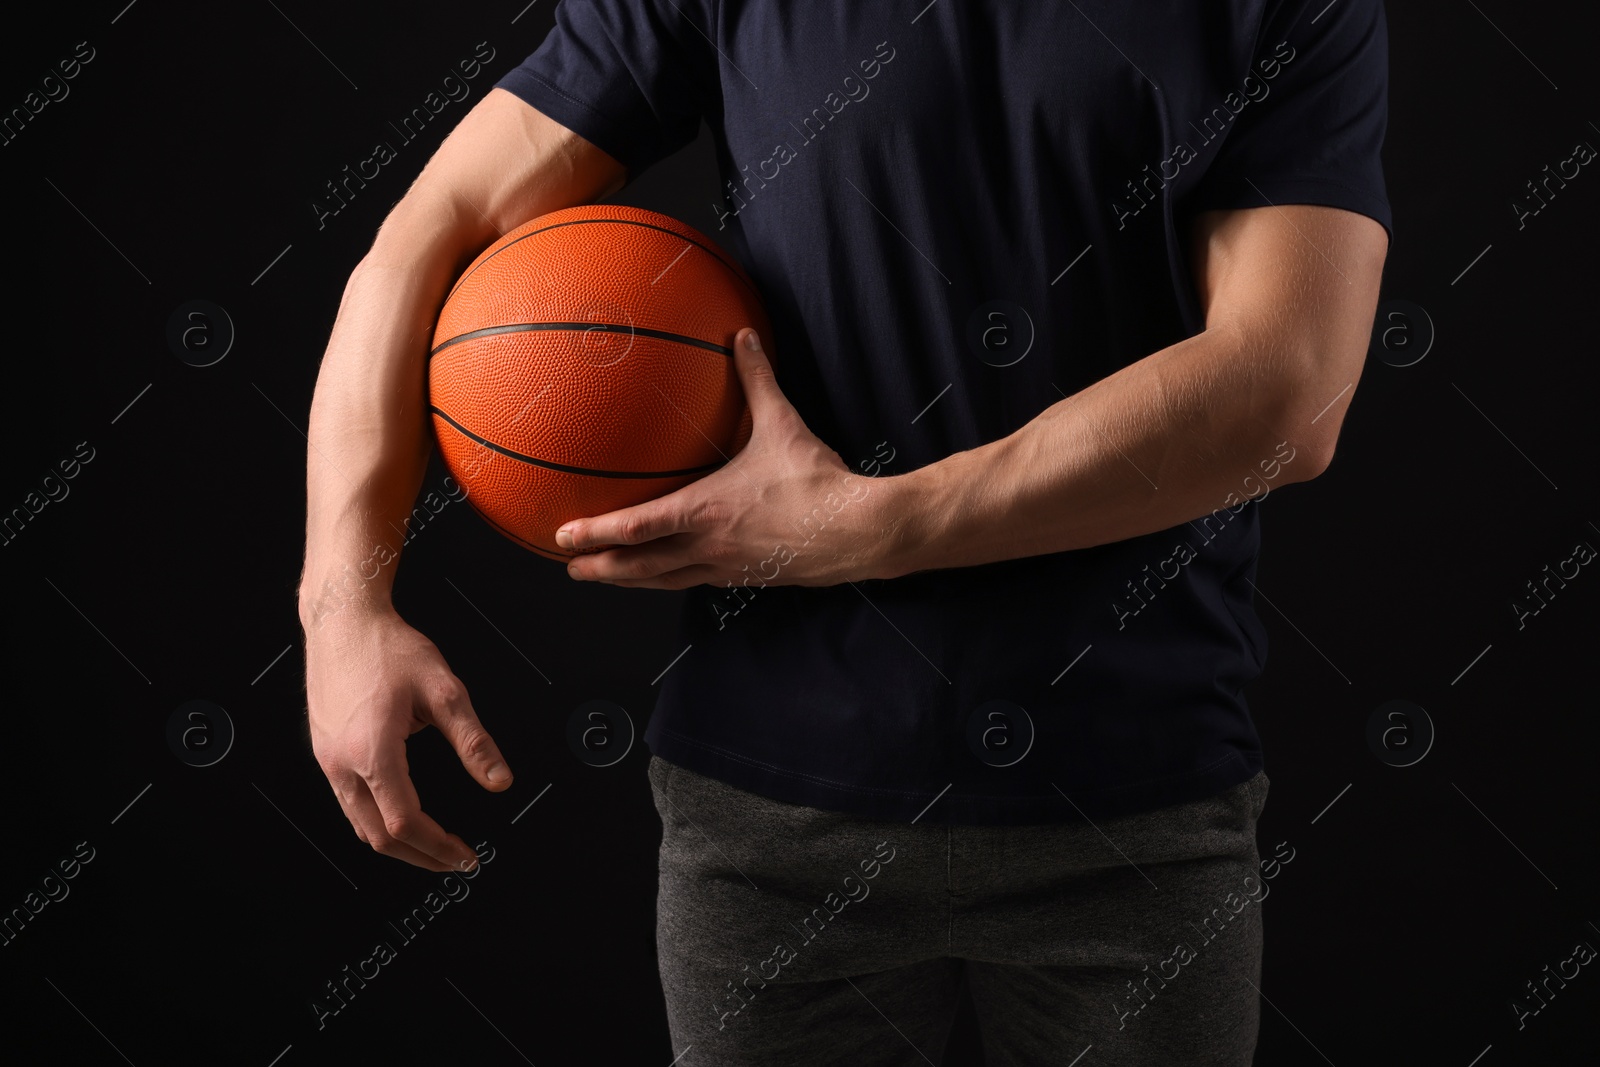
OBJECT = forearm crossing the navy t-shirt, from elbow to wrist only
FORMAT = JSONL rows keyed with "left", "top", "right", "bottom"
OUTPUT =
{"left": 883, "top": 321, "right": 1350, "bottom": 576}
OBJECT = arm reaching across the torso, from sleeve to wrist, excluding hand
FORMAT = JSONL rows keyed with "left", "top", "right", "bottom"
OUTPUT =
{"left": 874, "top": 205, "right": 1389, "bottom": 577}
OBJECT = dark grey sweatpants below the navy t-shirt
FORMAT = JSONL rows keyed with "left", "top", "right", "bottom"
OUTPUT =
{"left": 650, "top": 757, "right": 1269, "bottom": 1067}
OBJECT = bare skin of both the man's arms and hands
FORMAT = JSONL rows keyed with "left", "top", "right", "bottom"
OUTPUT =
{"left": 299, "top": 88, "right": 1387, "bottom": 872}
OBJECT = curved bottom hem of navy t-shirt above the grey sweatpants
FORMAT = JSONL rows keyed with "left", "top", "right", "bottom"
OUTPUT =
{"left": 645, "top": 726, "right": 1262, "bottom": 825}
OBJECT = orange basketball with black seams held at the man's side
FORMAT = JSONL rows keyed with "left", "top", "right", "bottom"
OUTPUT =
{"left": 427, "top": 205, "right": 771, "bottom": 560}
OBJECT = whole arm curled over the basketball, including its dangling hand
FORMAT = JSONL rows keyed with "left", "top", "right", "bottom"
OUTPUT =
{"left": 299, "top": 88, "right": 624, "bottom": 870}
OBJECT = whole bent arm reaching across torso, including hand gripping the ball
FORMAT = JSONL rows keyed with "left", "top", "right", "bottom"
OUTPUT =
{"left": 557, "top": 205, "right": 1389, "bottom": 589}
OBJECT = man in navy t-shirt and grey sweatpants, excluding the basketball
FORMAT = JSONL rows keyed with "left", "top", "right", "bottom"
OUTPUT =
{"left": 301, "top": 0, "right": 1390, "bottom": 1064}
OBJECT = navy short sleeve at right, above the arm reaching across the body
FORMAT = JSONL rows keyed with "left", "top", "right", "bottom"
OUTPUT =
{"left": 1181, "top": 0, "right": 1394, "bottom": 237}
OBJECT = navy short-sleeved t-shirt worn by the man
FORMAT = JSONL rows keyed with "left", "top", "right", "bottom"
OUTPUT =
{"left": 499, "top": 0, "right": 1390, "bottom": 824}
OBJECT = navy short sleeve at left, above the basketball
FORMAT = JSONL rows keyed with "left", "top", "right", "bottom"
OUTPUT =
{"left": 494, "top": 0, "right": 717, "bottom": 179}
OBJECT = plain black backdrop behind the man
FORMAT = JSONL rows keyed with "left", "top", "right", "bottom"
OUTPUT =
{"left": 0, "top": 0, "right": 1600, "bottom": 1067}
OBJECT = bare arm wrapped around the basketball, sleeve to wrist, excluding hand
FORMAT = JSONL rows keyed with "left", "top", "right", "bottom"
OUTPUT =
{"left": 299, "top": 88, "right": 626, "bottom": 632}
